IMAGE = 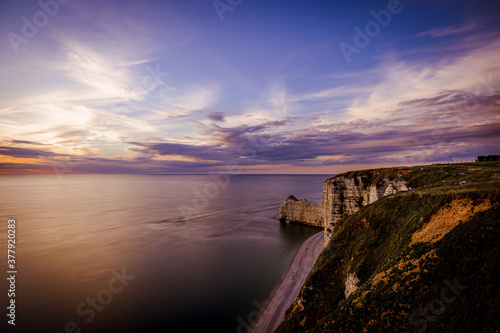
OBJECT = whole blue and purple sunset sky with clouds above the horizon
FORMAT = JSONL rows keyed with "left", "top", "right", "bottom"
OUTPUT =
{"left": 0, "top": 0, "right": 500, "bottom": 175}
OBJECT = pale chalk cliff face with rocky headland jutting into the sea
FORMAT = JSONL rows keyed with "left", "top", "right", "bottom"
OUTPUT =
{"left": 280, "top": 168, "right": 410, "bottom": 244}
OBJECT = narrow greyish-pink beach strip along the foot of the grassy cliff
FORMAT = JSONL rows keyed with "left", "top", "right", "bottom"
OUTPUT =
{"left": 251, "top": 231, "right": 324, "bottom": 333}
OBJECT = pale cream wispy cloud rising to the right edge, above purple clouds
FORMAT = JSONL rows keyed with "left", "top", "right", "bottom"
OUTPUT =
{"left": 348, "top": 40, "right": 500, "bottom": 119}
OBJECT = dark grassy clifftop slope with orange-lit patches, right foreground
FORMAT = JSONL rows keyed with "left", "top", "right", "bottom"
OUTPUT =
{"left": 277, "top": 162, "right": 500, "bottom": 332}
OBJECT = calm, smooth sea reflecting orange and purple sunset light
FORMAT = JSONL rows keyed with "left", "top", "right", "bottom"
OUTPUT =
{"left": 0, "top": 175, "right": 327, "bottom": 333}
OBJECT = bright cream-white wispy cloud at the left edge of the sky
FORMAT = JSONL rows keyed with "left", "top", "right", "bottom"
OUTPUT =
{"left": 0, "top": 36, "right": 163, "bottom": 160}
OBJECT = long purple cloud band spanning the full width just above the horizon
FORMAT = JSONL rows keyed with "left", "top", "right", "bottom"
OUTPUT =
{"left": 0, "top": 91, "right": 500, "bottom": 173}
